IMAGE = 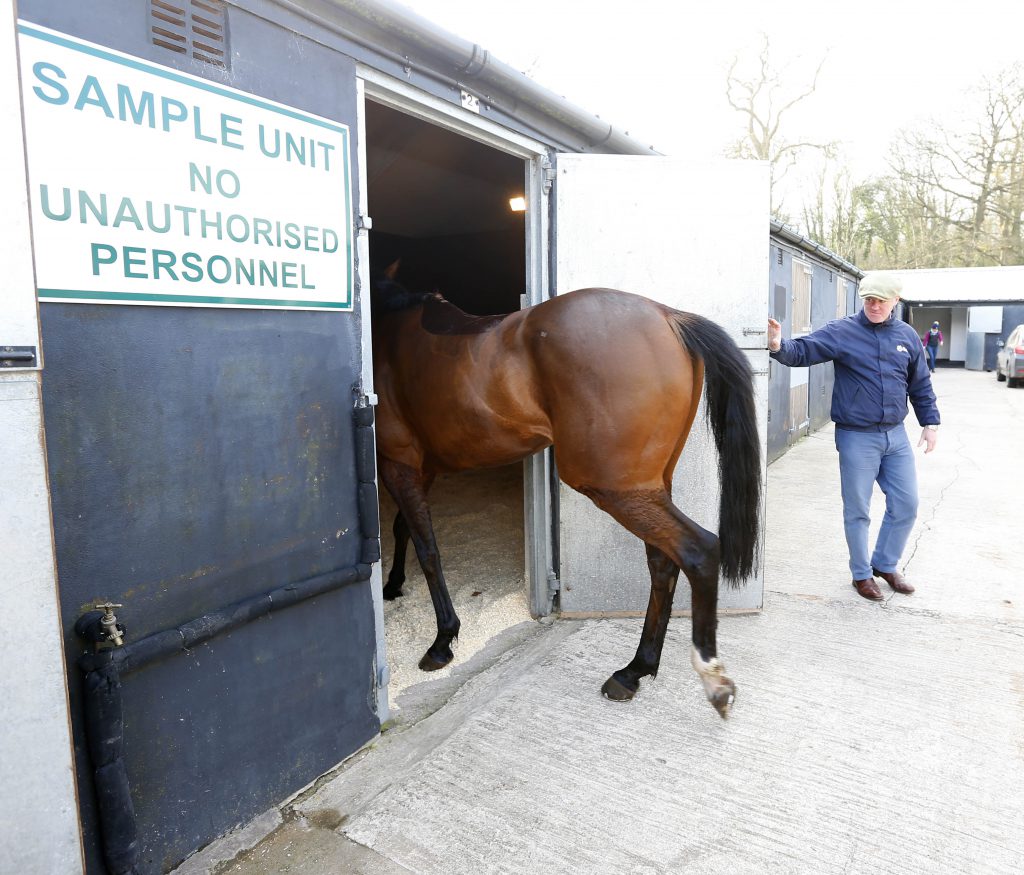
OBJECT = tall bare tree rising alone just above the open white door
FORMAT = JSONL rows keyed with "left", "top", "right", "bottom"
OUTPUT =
{"left": 725, "top": 36, "right": 835, "bottom": 219}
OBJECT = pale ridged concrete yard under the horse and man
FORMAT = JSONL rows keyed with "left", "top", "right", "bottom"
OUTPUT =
{"left": 184, "top": 369, "right": 1024, "bottom": 875}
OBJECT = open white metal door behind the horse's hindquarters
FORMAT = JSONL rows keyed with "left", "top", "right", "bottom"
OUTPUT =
{"left": 555, "top": 155, "right": 769, "bottom": 616}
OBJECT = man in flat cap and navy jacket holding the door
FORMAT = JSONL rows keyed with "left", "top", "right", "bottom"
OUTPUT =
{"left": 768, "top": 273, "right": 939, "bottom": 601}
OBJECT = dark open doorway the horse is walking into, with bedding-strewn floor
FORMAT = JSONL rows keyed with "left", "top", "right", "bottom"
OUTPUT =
{"left": 365, "top": 99, "right": 532, "bottom": 719}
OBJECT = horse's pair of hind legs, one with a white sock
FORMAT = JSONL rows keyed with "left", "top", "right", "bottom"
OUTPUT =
{"left": 586, "top": 489, "right": 736, "bottom": 717}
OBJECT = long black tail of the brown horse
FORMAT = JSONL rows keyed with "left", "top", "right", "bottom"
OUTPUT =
{"left": 672, "top": 311, "right": 761, "bottom": 587}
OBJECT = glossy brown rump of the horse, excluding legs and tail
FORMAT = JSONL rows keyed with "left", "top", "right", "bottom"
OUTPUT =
{"left": 516, "top": 289, "right": 702, "bottom": 489}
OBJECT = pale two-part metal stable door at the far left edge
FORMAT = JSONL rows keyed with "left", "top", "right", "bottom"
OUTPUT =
{"left": 0, "top": 0, "right": 83, "bottom": 875}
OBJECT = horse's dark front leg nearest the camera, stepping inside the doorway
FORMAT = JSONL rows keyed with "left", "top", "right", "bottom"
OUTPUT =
{"left": 379, "top": 459, "right": 461, "bottom": 671}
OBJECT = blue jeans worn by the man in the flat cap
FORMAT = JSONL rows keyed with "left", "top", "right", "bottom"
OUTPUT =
{"left": 836, "top": 424, "right": 918, "bottom": 580}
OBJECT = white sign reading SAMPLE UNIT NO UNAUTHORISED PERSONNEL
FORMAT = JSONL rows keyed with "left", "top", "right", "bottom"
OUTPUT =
{"left": 18, "top": 20, "right": 352, "bottom": 310}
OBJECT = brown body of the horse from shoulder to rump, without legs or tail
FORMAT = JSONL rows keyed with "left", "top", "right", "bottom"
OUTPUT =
{"left": 375, "top": 289, "right": 694, "bottom": 480}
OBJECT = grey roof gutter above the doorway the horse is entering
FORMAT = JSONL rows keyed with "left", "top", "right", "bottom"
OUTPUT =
{"left": 328, "top": 0, "right": 657, "bottom": 155}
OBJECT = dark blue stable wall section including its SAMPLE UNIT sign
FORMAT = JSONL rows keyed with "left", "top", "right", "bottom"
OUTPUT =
{"left": 19, "top": 0, "right": 380, "bottom": 873}
